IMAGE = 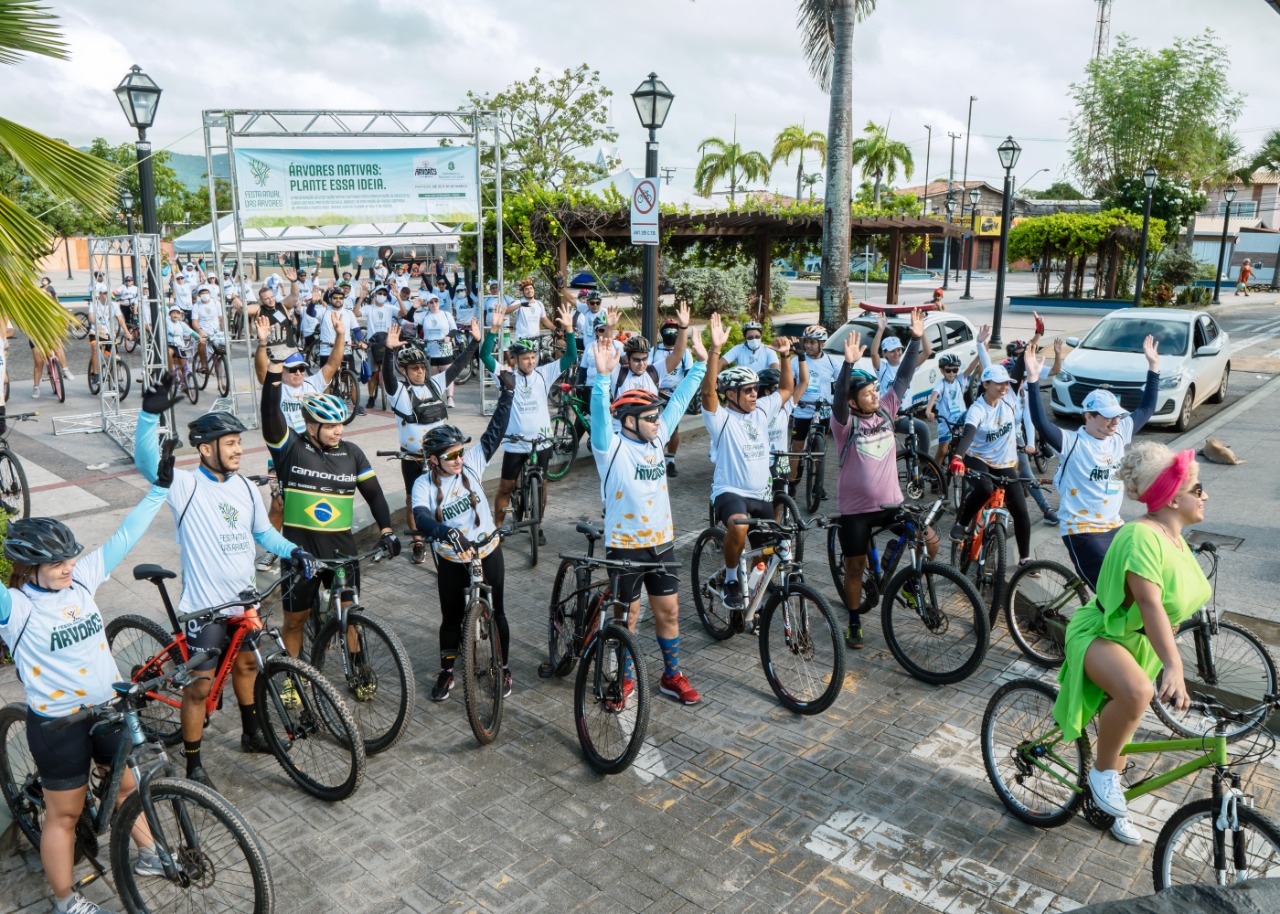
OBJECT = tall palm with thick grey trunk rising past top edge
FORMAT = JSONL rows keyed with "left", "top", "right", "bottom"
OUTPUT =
{"left": 796, "top": 0, "right": 876, "bottom": 328}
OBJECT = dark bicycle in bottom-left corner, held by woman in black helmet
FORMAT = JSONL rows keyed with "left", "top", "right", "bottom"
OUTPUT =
{"left": 0, "top": 661, "right": 275, "bottom": 914}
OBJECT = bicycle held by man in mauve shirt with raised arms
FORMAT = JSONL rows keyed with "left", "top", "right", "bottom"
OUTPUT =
{"left": 827, "top": 498, "right": 991, "bottom": 685}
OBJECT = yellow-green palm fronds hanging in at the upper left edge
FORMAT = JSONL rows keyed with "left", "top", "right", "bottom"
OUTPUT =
{"left": 0, "top": 0, "right": 119, "bottom": 351}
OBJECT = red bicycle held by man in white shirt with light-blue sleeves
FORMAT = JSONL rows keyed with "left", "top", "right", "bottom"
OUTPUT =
{"left": 106, "top": 565, "right": 366, "bottom": 801}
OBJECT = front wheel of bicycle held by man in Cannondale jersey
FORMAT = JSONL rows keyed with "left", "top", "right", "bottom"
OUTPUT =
{"left": 311, "top": 612, "right": 417, "bottom": 755}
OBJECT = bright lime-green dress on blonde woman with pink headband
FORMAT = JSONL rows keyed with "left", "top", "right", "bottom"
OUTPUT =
{"left": 1053, "top": 521, "right": 1212, "bottom": 740}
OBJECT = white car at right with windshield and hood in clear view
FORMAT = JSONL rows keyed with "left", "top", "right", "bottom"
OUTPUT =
{"left": 1050, "top": 307, "right": 1231, "bottom": 431}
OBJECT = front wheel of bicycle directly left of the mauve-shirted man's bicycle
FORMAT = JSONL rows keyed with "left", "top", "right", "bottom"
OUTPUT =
{"left": 759, "top": 581, "right": 845, "bottom": 714}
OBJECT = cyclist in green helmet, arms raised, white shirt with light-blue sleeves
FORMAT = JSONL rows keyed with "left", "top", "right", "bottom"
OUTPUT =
{"left": 491, "top": 305, "right": 577, "bottom": 529}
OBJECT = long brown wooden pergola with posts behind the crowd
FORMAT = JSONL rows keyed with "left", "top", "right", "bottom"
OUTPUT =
{"left": 557, "top": 211, "right": 972, "bottom": 305}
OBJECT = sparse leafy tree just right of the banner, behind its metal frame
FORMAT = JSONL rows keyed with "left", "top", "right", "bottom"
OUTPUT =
{"left": 467, "top": 64, "right": 618, "bottom": 191}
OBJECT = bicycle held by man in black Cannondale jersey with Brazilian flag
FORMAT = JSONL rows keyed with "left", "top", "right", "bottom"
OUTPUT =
{"left": 303, "top": 547, "right": 417, "bottom": 755}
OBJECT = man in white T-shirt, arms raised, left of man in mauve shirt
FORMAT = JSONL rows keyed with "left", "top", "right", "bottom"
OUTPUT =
{"left": 701, "top": 314, "right": 794, "bottom": 613}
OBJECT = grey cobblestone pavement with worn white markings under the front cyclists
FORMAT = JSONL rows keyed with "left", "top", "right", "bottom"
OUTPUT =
{"left": 0, "top": 399, "right": 1277, "bottom": 914}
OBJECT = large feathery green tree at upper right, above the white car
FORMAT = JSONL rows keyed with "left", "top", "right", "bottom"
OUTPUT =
{"left": 1070, "top": 29, "right": 1243, "bottom": 196}
